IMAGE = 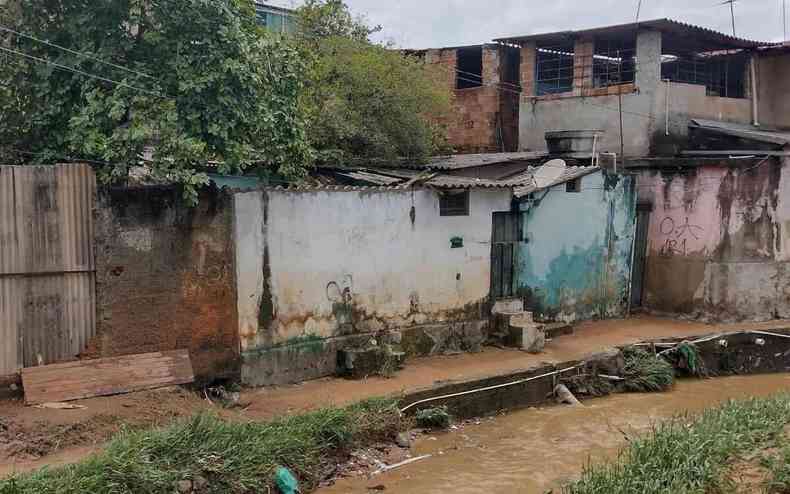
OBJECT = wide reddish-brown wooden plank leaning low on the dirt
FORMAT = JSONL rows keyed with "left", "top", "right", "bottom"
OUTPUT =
{"left": 22, "top": 350, "right": 195, "bottom": 405}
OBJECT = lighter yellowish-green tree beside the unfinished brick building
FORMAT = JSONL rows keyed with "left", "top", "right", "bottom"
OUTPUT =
{"left": 296, "top": 0, "right": 452, "bottom": 163}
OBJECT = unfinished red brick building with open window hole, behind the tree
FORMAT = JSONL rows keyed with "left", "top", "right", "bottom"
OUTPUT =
{"left": 410, "top": 44, "right": 521, "bottom": 153}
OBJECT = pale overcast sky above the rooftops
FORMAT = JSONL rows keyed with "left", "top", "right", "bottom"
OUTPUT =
{"left": 272, "top": 0, "right": 790, "bottom": 48}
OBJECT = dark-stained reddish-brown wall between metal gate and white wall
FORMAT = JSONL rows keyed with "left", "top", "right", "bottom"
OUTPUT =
{"left": 89, "top": 187, "right": 239, "bottom": 379}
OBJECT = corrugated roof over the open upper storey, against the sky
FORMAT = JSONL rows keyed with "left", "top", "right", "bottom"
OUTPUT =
{"left": 495, "top": 19, "right": 770, "bottom": 49}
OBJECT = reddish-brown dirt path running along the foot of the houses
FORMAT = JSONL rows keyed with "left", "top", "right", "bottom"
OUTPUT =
{"left": 0, "top": 317, "right": 790, "bottom": 477}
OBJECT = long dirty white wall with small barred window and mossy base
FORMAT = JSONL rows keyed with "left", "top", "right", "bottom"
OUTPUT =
{"left": 235, "top": 190, "right": 511, "bottom": 384}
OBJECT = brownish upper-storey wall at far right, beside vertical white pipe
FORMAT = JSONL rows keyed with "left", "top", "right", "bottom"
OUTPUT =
{"left": 757, "top": 50, "right": 790, "bottom": 129}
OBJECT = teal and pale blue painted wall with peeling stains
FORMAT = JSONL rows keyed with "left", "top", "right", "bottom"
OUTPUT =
{"left": 516, "top": 172, "right": 636, "bottom": 322}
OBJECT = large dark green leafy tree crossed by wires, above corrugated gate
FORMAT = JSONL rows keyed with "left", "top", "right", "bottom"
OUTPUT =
{"left": 0, "top": 0, "right": 312, "bottom": 202}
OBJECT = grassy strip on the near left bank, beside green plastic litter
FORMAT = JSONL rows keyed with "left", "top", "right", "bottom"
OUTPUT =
{"left": 0, "top": 400, "right": 402, "bottom": 494}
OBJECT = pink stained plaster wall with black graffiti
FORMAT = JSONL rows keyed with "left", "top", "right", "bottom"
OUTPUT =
{"left": 639, "top": 159, "right": 790, "bottom": 321}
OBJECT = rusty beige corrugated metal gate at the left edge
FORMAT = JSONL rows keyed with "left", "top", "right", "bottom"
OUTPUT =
{"left": 0, "top": 165, "right": 96, "bottom": 375}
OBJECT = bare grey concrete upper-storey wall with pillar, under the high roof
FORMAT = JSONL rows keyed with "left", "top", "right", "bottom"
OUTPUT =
{"left": 519, "top": 31, "right": 752, "bottom": 156}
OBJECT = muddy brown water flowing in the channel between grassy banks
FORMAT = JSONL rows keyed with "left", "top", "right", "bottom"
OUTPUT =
{"left": 319, "top": 374, "right": 790, "bottom": 494}
